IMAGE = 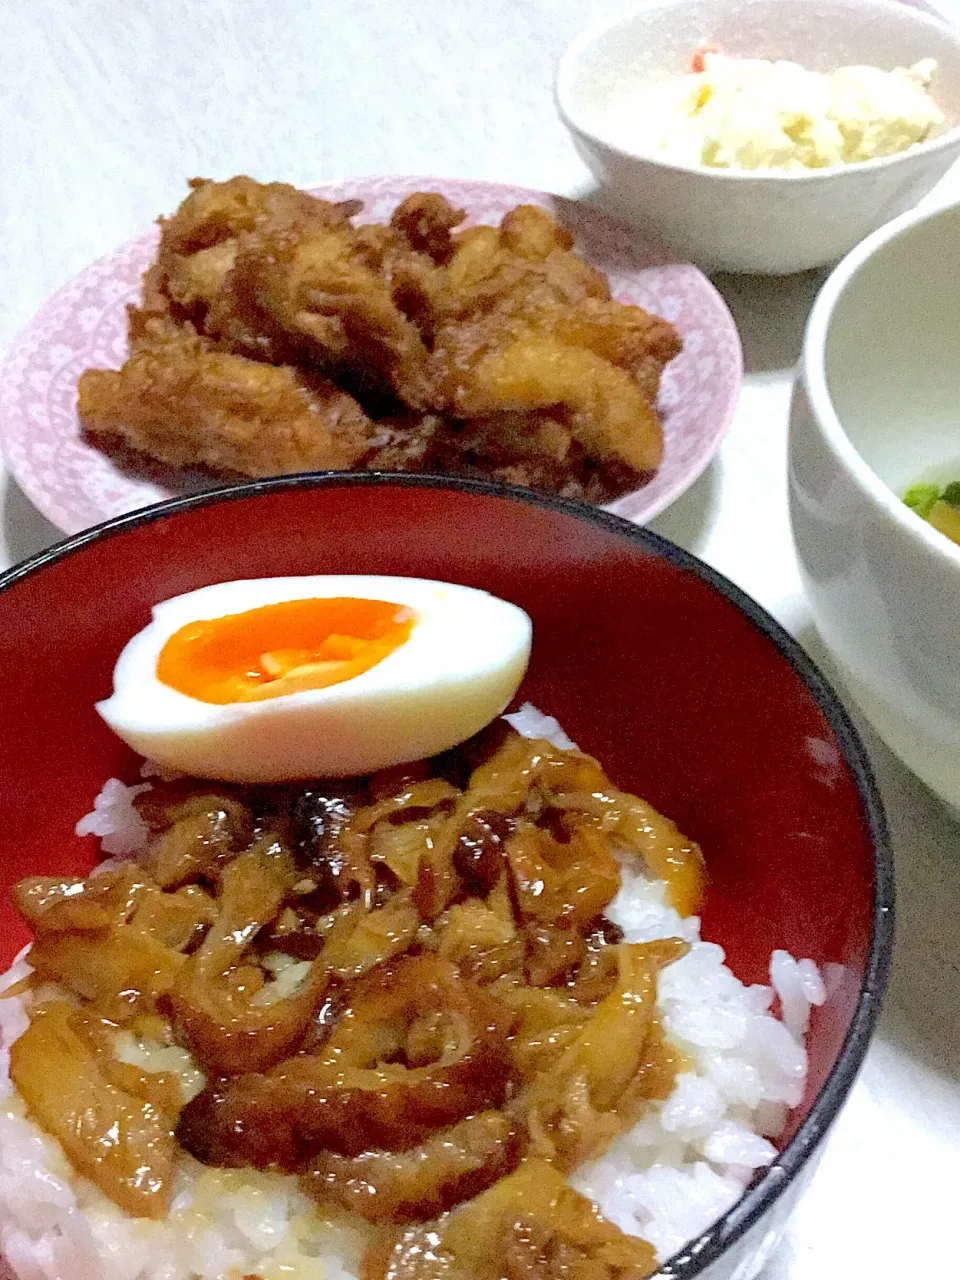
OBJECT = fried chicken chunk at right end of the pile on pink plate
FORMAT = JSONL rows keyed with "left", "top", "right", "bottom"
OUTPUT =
{"left": 401, "top": 205, "right": 680, "bottom": 472}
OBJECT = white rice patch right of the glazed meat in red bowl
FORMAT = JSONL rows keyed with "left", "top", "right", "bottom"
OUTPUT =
{"left": 571, "top": 867, "right": 824, "bottom": 1261}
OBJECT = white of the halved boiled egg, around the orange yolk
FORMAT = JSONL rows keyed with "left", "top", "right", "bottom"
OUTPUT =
{"left": 97, "top": 575, "right": 532, "bottom": 782}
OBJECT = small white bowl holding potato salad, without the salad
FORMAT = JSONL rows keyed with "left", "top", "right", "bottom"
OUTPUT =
{"left": 556, "top": 0, "right": 960, "bottom": 274}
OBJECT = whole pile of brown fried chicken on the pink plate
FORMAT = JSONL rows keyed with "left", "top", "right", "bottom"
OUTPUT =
{"left": 79, "top": 177, "right": 681, "bottom": 502}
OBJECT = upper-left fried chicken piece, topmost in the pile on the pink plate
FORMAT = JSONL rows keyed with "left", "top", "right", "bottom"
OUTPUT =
{"left": 160, "top": 178, "right": 450, "bottom": 386}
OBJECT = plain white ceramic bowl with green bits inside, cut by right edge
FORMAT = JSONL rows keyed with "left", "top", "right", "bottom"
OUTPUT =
{"left": 790, "top": 195, "right": 960, "bottom": 805}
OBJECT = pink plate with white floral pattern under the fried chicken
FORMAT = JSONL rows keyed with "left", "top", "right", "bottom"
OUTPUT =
{"left": 0, "top": 177, "right": 742, "bottom": 534}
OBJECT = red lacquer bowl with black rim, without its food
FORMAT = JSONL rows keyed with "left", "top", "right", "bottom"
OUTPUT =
{"left": 0, "top": 475, "right": 893, "bottom": 1280}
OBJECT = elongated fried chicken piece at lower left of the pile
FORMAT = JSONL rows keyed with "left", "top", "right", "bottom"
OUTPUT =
{"left": 78, "top": 317, "right": 372, "bottom": 476}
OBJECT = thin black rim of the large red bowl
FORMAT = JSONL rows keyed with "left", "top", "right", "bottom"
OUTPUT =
{"left": 0, "top": 471, "right": 895, "bottom": 1280}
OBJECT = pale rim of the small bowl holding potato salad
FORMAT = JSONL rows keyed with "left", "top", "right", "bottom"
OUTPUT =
{"left": 553, "top": 0, "right": 960, "bottom": 184}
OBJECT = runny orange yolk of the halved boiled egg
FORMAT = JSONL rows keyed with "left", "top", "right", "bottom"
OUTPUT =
{"left": 156, "top": 598, "right": 417, "bottom": 705}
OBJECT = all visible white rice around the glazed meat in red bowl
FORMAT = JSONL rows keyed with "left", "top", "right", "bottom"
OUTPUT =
{"left": 0, "top": 721, "right": 826, "bottom": 1280}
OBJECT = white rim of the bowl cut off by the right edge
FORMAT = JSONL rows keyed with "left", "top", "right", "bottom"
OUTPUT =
{"left": 800, "top": 200, "right": 960, "bottom": 566}
